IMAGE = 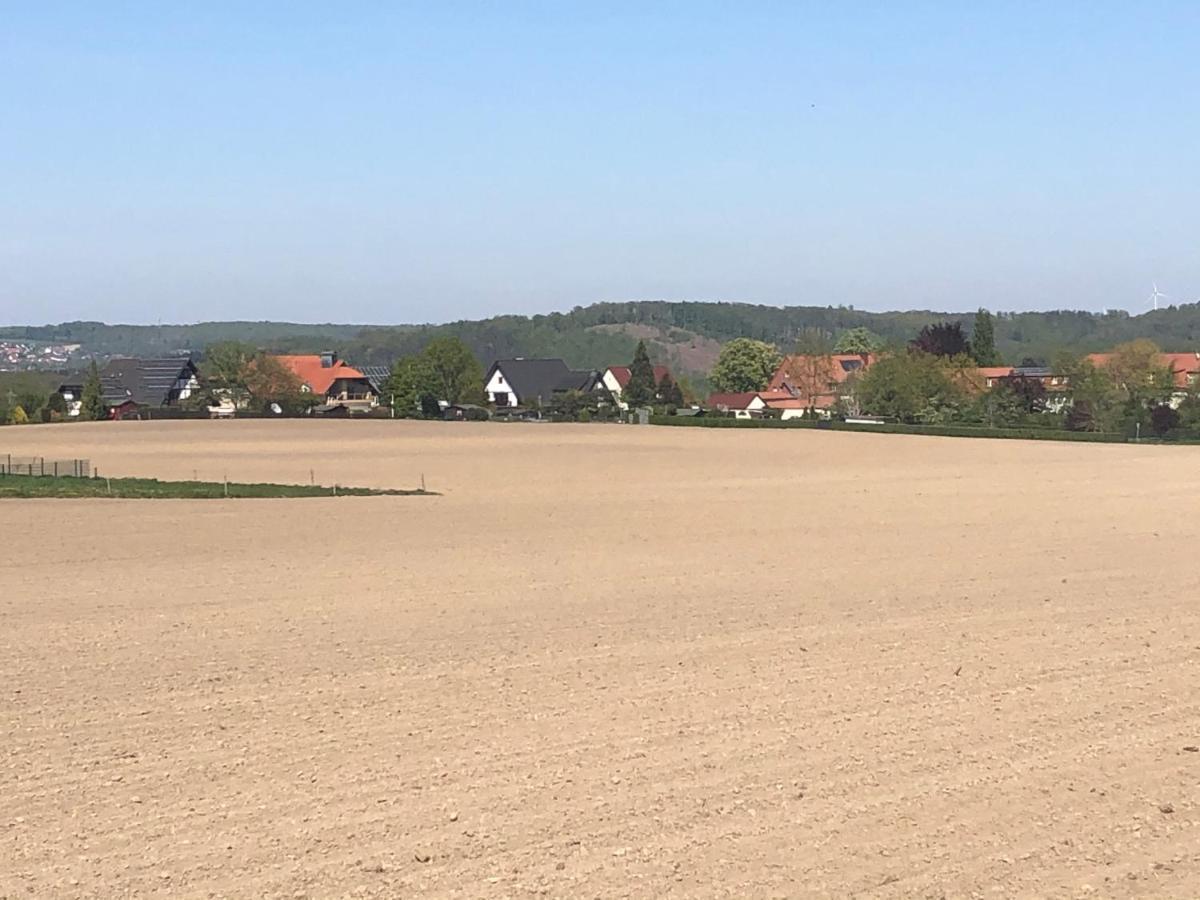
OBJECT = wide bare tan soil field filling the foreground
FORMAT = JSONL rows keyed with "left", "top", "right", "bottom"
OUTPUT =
{"left": 0, "top": 421, "right": 1200, "bottom": 898}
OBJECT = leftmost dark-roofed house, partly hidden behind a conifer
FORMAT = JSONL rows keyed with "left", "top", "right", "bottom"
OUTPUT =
{"left": 59, "top": 356, "right": 200, "bottom": 419}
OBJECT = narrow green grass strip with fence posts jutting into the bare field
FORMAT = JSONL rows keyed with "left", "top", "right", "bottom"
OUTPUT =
{"left": 0, "top": 475, "right": 436, "bottom": 500}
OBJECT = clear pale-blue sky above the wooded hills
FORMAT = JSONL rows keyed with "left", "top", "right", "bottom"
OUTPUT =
{"left": 0, "top": 0, "right": 1200, "bottom": 323}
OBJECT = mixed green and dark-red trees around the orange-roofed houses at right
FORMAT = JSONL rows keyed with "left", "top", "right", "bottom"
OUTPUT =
{"left": 712, "top": 310, "right": 1200, "bottom": 439}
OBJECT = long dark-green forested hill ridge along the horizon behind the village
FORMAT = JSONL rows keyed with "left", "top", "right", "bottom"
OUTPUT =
{"left": 7, "top": 301, "right": 1200, "bottom": 374}
